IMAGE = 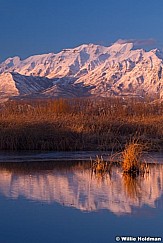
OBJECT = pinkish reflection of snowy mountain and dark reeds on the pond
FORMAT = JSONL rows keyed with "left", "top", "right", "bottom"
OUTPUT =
{"left": 0, "top": 161, "right": 163, "bottom": 215}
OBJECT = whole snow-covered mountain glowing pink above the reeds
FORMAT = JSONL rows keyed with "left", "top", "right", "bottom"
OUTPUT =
{"left": 0, "top": 42, "right": 163, "bottom": 98}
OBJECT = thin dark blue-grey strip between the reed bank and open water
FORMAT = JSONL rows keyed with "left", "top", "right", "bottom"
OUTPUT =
{"left": 0, "top": 151, "right": 163, "bottom": 164}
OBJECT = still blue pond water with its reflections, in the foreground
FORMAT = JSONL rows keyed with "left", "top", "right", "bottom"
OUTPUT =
{"left": 0, "top": 152, "right": 163, "bottom": 243}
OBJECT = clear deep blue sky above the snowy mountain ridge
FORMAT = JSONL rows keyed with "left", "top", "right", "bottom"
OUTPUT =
{"left": 0, "top": 0, "right": 163, "bottom": 61}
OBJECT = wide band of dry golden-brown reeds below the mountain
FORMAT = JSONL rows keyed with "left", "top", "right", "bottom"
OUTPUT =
{"left": 0, "top": 98, "right": 163, "bottom": 151}
